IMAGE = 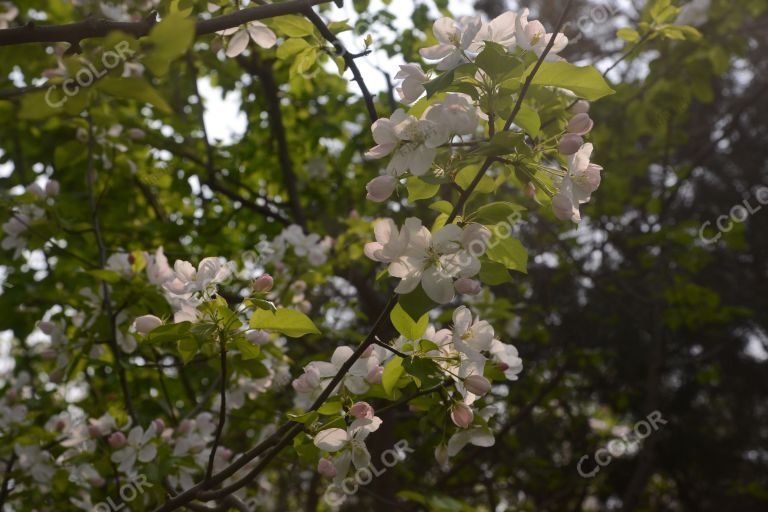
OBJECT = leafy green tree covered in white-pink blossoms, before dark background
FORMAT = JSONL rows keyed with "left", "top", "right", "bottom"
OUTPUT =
{"left": 0, "top": 0, "right": 764, "bottom": 511}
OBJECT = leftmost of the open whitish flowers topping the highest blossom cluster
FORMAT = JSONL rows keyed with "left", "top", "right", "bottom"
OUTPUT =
{"left": 419, "top": 16, "right": 482, "bottom": 71}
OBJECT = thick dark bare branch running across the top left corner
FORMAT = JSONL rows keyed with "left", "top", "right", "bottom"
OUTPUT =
{"left": 0, "top": 0, "right": 341, "bottom": 48}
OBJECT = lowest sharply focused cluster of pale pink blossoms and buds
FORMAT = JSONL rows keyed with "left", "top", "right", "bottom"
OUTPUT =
{"left": 293, "top": 306, "right": 523, "bottom": 483}
